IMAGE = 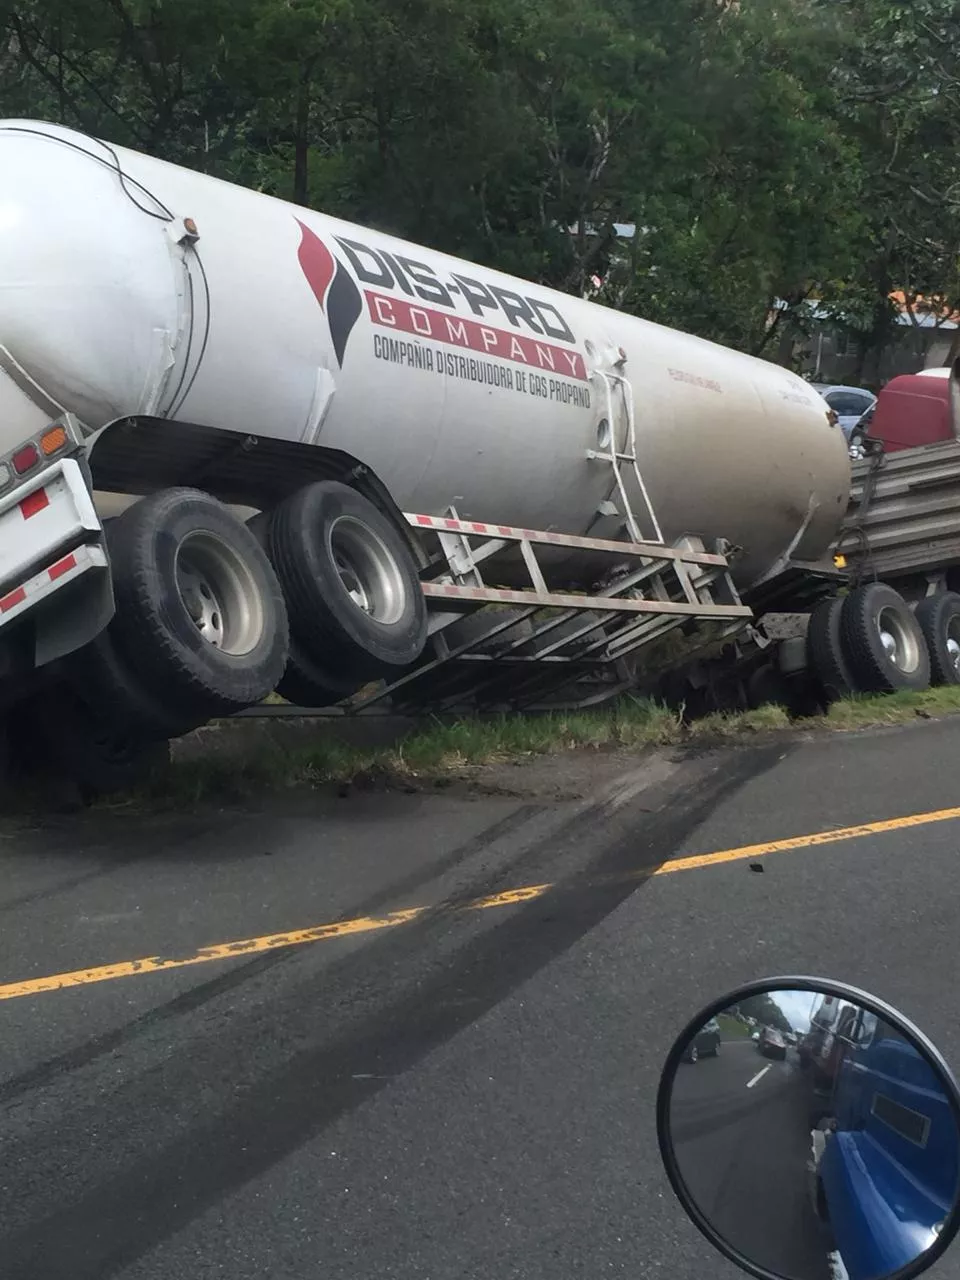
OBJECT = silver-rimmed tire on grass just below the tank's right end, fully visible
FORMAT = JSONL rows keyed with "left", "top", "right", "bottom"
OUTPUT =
{"left": 841, "top": 582, "right": 931, "bottom": 694}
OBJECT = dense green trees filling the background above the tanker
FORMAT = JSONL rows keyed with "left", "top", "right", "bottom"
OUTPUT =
{"left": 0, "top": 0, "right": 960, "bottom": 358}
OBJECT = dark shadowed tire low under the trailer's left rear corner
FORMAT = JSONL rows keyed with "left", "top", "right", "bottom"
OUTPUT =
{"left": 31, "top": 686, "right": 170, "bottom": 803}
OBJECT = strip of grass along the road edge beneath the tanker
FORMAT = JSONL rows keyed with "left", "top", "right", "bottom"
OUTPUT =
{"left": 136, "top": 687, "right": 960, "bottom": 801}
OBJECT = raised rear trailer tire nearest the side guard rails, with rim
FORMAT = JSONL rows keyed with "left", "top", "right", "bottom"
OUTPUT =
{"left": 268, "top": 480, "right": 426, "bottom": 684}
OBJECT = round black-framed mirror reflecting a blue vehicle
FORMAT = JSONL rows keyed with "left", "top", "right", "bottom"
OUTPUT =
{"left": 657, "top": 977, "right": 960, "bottom": 1280}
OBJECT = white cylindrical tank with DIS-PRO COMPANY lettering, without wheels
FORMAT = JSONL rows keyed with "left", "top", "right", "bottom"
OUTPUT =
{"left": 0, "top": 120, "right": 850, "bottom": 584}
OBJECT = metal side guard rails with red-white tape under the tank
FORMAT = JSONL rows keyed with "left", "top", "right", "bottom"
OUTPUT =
{"left": 264, "top": 508, "right": 754, "bottom": 716}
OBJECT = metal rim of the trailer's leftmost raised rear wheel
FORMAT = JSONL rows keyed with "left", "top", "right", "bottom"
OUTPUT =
{"left": 175, "top": 530, "right": 264, "bottom": 657}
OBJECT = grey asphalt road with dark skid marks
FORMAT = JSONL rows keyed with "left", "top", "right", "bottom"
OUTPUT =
{"left": 0, "top": 723, "right": 960, "bottom": 1280}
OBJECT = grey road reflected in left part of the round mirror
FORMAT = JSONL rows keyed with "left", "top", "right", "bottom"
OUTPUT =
{"left": 671, "top": 1024, "right": 844, "bottom": 1280}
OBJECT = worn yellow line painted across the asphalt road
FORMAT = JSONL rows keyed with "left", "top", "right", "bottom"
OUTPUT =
{"left": 0, "top": 808, "right": 960, "bottom": 1000}
